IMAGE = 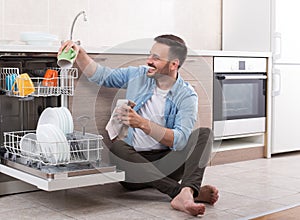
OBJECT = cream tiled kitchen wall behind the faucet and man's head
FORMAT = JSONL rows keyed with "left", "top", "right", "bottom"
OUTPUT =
{"left": 0, "top": 0, "right": 222, "bottom": 50}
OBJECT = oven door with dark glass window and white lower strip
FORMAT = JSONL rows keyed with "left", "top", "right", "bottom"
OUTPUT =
{"left": 213, "top": 74, "right": 267, "bottom": 137}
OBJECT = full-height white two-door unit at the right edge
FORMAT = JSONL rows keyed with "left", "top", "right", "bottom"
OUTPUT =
{"left": 270, "top": 0, "right": 300, "bottom": 154}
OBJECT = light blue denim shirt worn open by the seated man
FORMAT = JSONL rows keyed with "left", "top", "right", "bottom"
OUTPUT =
{"left": 89, "top": 65, "right": 198, "bottom": 151}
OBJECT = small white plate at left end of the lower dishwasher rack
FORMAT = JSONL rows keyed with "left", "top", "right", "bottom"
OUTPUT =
{"left": 20, "top": 133, "right": 40, "bottom": 157}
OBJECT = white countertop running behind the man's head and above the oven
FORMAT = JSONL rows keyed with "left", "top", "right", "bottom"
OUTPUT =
{"left": 0, "top": 44, "right": 272, "bottom": 57}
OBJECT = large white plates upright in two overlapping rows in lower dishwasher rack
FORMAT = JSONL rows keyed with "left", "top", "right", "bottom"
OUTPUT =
{"left": 36, "top": 107, "right": 74, "bottom": 164}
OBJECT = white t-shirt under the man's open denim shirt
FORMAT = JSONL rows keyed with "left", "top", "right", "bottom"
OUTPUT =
{"left": 132, "top": 87, "right": 169, "bottom": 151}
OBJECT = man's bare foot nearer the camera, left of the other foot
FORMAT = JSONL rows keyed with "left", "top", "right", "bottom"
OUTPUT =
{"left": 171, "top": 187, "right": 205, "bottom": 216}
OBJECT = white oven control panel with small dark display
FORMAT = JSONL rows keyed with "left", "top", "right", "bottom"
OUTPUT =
{"left": 214, "top": 57, "right": 267, "bottom": 73}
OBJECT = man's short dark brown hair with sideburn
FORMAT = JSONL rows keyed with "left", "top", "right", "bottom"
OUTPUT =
{"left": 154, "top": 34, "right": 187, "bottom": 68}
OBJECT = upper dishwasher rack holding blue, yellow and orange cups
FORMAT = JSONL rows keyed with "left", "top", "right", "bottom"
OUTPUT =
{"left": 0, "top": 68, "right": 78, "bottom": 98}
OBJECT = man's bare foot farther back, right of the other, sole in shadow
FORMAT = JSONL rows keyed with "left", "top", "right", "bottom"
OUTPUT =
{"left": 195, "top": 185, "right": 219, "bottom": 205}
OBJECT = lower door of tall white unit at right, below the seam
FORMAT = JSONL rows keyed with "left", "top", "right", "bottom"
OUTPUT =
{"left": 271, "top": 65, "right": 300, "bottom": 153}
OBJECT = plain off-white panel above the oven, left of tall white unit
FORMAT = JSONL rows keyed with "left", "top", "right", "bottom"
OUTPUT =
{"left": 222, "top": 0, "right": 272, "bottom": 52}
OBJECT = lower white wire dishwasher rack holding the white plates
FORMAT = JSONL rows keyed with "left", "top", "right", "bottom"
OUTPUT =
{"left": 4, "top": 130, "right": 103, "bottom": 168}
